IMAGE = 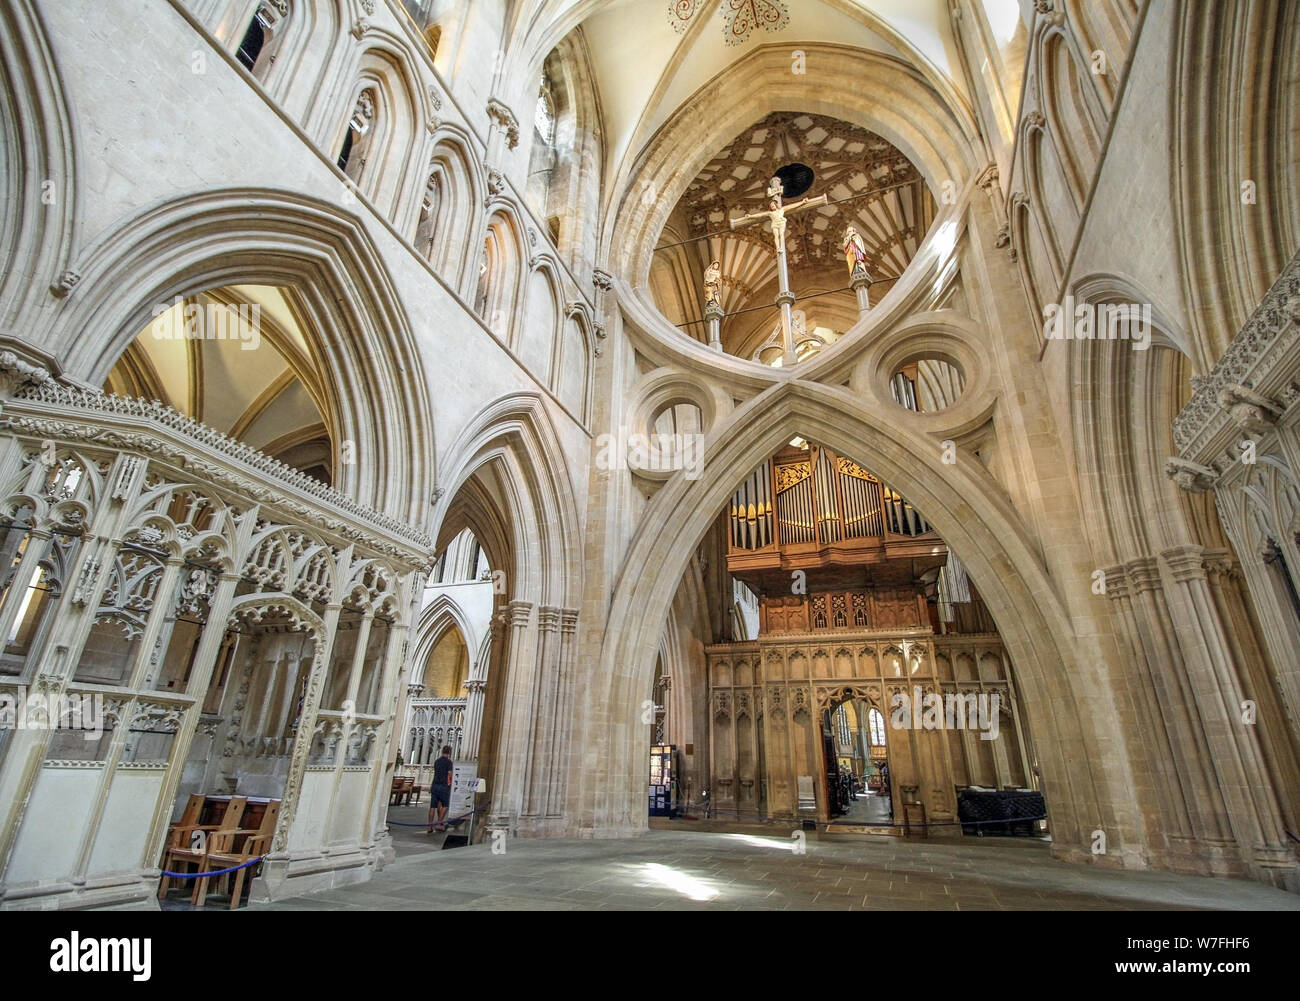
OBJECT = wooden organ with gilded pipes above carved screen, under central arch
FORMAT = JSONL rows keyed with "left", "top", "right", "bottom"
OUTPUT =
{"left": 706, "top": 438, "right": 1036, "bottom": 836}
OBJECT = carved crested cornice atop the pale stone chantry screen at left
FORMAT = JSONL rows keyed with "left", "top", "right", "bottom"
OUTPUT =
{"left": 3, "top": 380, "right": 433, "bottom": 564}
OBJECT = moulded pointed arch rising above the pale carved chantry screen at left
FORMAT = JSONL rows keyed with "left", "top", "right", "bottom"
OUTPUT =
{"left": 40, "top": 189, "right": 434, "bottom": 527}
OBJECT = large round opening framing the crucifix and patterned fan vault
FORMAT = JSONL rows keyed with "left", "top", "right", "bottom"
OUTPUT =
{"left": 650, "top": 112, "right": 936, "bottom": 365}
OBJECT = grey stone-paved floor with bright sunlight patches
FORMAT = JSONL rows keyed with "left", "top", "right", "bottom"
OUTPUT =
{"left": 250, "top": 807, "right": 1300, "bottom": 911}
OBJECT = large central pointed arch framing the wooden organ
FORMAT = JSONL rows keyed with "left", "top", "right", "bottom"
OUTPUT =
{"left": 585, "top": 382, "right": 1143, "bottom": 865}
